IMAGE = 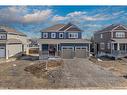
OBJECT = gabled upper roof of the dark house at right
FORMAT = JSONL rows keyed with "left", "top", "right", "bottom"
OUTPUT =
{"left": 96, "top": 24, "right": 127, "bottom": 32}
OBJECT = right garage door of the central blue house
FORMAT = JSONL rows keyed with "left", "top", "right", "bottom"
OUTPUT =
{"left": 75, "top": 47, "right": 88, "bottom": 58}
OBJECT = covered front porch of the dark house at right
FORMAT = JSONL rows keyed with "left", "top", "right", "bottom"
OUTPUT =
{"left": 111, "top": 39, "right": 127, "bottom": 58}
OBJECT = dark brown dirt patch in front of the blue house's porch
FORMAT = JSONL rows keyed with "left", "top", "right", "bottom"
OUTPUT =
{"left": 24, "top": 60, "right": 63, "bottom": 78}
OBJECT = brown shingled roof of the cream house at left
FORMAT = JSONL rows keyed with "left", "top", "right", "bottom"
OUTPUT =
{"left": 0, "top": 26, "right": 27, "bottom": 36}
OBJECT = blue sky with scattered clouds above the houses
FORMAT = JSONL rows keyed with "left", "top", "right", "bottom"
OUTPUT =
{"left": 0, "top": 6, "right": 127, "bottom": 39}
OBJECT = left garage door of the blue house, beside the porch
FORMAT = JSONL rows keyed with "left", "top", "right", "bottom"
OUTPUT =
{"left": 61, "top": 46, "right": 74, "bottom": 59}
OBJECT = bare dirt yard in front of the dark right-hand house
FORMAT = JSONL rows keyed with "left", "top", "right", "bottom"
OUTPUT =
{"left": 90, "top": 57, "right": 127, "bottom": 78}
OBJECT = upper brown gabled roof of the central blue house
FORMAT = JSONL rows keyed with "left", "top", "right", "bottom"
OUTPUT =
{"left": 41, "top": 23, "right": 81, "bottom": 32}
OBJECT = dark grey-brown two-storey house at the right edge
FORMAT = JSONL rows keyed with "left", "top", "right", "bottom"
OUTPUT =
{"left": 94, "top": 24, "right": 127, "bottom": 59}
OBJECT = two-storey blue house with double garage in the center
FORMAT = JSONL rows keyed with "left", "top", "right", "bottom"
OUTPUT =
{"left": 39, "top": 23, "right": 90, "bottom": 59}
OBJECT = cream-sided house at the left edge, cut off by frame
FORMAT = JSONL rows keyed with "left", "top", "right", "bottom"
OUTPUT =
{"left": 0, "top": 26, "right": 27, "bottom": 59}
